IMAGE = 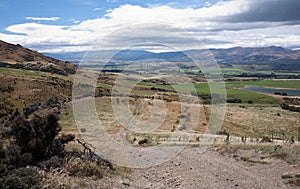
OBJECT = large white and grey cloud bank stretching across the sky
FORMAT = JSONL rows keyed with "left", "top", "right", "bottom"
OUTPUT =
{"left": 0, "top": 0, "right": 300, "bottom": 51}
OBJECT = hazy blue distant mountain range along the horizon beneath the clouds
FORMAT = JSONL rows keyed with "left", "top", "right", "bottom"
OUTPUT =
{"left": 45, "top": 46, "right": 300, "bottom": 70}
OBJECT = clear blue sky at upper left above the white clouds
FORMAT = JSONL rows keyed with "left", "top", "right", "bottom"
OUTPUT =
{"left": 0, "top": 0, "right": 217, "bottom": 32}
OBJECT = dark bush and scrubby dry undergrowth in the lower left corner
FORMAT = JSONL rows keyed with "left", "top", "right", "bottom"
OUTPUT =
{"left": 0, "top": 102, "right": 113, "bottom": 189}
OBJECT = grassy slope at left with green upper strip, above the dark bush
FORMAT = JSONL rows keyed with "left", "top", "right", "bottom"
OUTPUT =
{"left": 0, "top": 68, "right": 73, "bottom": 124}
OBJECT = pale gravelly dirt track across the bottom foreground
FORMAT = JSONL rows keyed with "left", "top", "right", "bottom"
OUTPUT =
{"left": 95, "top": 148, "right": 300, "bottom": 189}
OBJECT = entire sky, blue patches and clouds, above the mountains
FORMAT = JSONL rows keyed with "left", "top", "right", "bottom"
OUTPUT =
{"left": 0, "top": 0, "right": 300, "bottom": 52}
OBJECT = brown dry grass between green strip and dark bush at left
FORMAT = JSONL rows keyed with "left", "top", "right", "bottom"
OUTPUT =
{"left": 0, "top": 71, "right": 72, "bottom": 113}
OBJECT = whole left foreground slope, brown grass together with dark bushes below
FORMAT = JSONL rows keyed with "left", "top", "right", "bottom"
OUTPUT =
{"left": 0, "top": 68, "right": 122, "bottom": 188}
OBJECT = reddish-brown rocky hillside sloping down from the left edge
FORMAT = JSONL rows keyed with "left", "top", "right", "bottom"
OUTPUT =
{"left": 0, "top": 40, "right": 76, "bottom": 75}
